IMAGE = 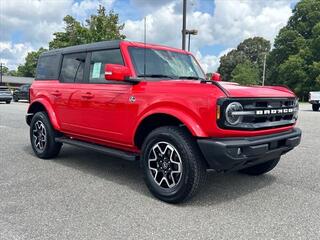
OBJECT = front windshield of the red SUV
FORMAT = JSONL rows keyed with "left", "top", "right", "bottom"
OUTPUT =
{"left": 129, "top": 47, "right": 205, "bottom": 79}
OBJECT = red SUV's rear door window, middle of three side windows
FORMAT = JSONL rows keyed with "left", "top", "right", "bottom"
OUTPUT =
{"left": 60, "top": 53, "right": 87, "bottom": 83}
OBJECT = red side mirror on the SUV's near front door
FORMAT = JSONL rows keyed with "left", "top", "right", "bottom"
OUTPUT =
{"left": 104, "top": 64, "right": 131, "bottom": 81}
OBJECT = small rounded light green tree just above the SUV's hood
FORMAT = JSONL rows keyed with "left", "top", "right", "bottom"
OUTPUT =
{"left": 231, "top": 60, "right": 259, "bottom": 85}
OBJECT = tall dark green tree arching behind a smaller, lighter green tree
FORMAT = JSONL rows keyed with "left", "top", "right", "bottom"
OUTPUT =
{"left": 218, "top": 37, "right": 271, "bottom": 81}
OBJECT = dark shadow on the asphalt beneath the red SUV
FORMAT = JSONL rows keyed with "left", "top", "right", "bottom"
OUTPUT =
{"left": 24, "top": 143, "right": 276, "bottom": 207}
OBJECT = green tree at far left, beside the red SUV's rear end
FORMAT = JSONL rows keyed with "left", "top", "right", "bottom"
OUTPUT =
{"left": 17, "top": 47, "right": 47, "bottom": 77}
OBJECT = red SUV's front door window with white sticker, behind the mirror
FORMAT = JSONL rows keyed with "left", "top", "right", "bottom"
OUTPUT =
{"left": 89, "top": 49, "right": 124, "bottom": 83}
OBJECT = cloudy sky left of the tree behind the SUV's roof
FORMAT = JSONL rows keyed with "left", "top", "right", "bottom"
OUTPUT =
{"left": 0, "top": 0, "right": 114, "bottom": 69}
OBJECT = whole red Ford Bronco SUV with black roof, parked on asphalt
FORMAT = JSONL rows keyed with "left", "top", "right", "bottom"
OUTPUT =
{"left": 26, "top": 41, "right": 301, "bottom": 202}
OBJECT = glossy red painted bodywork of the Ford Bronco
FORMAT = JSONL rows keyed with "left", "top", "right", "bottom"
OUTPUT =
{"left": 30, "top": 41, "right": 294, "bottom": 151}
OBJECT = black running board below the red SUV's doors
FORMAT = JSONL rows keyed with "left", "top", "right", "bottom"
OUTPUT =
{"left": 55, "top": 137, "right": 139, "bottom": 161}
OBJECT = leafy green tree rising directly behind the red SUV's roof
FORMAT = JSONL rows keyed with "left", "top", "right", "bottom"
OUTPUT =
{"left": 49, "top": 5, "right": 125, "bottom": 49}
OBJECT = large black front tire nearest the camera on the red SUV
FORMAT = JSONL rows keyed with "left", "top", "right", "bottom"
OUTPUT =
{"left": 141, "top": 126, "right": 206, "bottom": 203}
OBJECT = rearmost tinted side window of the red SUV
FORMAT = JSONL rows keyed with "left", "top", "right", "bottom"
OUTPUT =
{"left": 36, "top": 54, "right": 60, "bottom": 80}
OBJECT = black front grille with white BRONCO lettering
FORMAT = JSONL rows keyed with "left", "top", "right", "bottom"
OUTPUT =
{"left": 218, "top": 98, "right": 298, "bottom": 130}
